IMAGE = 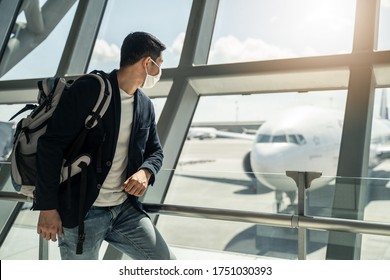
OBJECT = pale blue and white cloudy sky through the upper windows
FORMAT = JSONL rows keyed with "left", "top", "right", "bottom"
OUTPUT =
{"left": 0, "top": 0, "right": 390, "bottom": 121}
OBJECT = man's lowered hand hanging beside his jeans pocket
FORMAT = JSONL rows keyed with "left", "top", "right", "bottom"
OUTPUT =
{"left": 37, "top": 209, "right": 62, "bottom": 241}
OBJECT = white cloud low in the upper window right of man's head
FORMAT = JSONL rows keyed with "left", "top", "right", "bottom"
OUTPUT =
{"left": 209, "top": 35, "right": 296, "bottom": 63}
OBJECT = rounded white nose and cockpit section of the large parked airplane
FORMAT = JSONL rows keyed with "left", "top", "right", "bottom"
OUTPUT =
{"left": 251, "top": 107, "right": 342, "bottom": 192}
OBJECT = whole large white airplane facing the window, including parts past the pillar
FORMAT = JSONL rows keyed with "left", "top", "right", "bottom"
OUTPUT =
{"left": 213, "top": 93, "right": 390, "bottom": 212}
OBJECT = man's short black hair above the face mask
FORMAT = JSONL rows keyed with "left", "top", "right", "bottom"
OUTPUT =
{"left": 120, "top": 32, "right": 166, "bottom": 67}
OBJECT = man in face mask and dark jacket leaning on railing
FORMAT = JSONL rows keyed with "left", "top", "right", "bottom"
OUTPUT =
{"left": 33, "top": 32, "right": 174, "bottom": 259}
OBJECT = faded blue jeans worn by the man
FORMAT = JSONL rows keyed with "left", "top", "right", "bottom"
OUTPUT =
{"left": 58, "top": 200, "right": 175, "bottom": 260}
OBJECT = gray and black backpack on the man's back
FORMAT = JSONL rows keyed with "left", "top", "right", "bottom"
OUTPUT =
{"left": 10, "top": 71, "right": 111, "bottom": 198}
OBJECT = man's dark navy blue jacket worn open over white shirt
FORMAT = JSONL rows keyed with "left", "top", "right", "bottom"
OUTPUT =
{"left": 33, "top": 70, "right": 163, "bottom": 227}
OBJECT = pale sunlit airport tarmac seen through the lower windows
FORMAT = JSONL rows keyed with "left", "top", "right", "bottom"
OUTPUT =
{"left": 0, "top": 139, "right": 390, "bottom": 260}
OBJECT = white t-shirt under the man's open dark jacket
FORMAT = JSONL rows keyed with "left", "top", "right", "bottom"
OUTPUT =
{"left": 93, "top": 89, "right": 134, "bottom": 207}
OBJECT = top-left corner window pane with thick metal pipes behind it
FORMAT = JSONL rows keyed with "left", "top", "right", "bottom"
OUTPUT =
{"left": 0, "top": 1, "right": 77, "bottom": 80}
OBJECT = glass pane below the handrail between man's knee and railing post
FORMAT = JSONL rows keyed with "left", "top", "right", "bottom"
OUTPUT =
{"left": 158, "top": 216, "right": 288, "bottom": 260}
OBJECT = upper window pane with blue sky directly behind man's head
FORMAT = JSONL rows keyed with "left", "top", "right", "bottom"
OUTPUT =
{"left": 88, "top": 0, "right": 192, "bottom": 71}
